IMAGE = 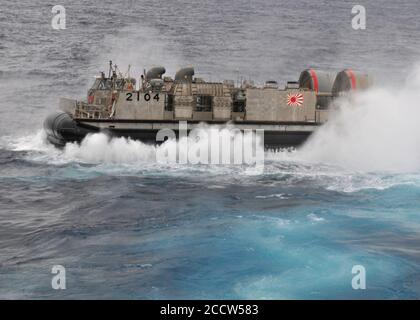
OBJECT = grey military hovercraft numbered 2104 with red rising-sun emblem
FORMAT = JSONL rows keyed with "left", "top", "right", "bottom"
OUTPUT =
{"left": 44, "top": 62, "right": 372, "bottom": 148}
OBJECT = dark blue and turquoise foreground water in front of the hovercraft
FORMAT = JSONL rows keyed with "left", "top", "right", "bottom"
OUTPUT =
{"left": 0, "top": 132, "right": 420, "bottom": 299}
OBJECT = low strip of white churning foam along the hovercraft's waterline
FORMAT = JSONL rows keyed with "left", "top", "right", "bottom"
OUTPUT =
{"left": 0, "top": 127, "right": 420, "bottom": 192}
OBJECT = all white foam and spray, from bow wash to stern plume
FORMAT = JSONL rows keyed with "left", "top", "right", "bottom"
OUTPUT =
{"left": 2, "top": 106, "right": 420, "bottom": 192}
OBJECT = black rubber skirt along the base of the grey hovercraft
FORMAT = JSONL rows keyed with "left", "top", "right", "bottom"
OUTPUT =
{"left": 44, "top": 112, "right": 319, "bottom": 148}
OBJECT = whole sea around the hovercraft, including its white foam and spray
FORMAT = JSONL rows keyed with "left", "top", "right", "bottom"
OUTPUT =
{"left": 0, "top": 0, "right": 420, "bottom": 299}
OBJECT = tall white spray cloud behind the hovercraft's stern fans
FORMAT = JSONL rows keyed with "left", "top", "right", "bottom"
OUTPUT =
{"left": 299, "top": 66, "right": 420, "bottom": 173}
